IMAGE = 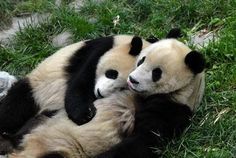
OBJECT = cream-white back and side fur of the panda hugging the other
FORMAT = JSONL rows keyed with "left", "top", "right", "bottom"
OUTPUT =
{"left": 27, "top": 41, "right": 84, "bottom": 110}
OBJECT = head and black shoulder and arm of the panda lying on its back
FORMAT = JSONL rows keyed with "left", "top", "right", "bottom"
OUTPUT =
{"left": 96, "top": 39, "right": 205, "bottom": 158}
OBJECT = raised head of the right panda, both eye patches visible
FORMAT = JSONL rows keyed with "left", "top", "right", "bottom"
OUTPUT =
{"left": 127, "top": 39, "right": 205, "bottom": 95}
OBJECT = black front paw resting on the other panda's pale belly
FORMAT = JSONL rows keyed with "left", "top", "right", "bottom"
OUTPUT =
{"left": 69, "top": 106, "right": 97, "bottom": 125}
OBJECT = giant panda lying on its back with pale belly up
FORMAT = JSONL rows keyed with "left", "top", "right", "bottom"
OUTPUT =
{"left": 7, "top": 39, "right": 205, "bottom": 158}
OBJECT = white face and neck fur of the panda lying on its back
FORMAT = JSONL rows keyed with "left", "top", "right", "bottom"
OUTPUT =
{"left": 127, "top": 39, "right": 204, "bottom": 110}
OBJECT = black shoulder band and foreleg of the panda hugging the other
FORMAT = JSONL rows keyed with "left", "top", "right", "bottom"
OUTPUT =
{"left": 65, "top": 37, "right": 114, "bottom": 125}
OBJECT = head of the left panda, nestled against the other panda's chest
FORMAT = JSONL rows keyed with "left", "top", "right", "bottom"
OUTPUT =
{"left": 94, "top": 37, "right": 144, "bottom": 98}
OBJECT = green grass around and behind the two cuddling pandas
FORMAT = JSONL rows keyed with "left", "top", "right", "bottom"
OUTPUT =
{"left": 0, "top": 0, "right": 236, "bottom": 158}
